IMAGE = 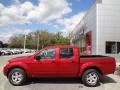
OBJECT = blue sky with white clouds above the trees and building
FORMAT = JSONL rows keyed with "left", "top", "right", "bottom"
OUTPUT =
{"left": 0, "top": 0, "right": 95, "bottom": 42}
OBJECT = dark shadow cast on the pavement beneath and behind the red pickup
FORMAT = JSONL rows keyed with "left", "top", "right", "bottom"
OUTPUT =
{"left": 26, "top": 76, "right": 117, "bottom": 85}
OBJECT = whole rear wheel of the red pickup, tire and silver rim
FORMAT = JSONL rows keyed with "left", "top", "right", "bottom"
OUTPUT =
{"left": 82, "top": 69, "right": 100, "bottom": 87}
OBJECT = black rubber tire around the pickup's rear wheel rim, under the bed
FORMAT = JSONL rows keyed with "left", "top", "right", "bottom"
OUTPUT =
{"left": 82, "top": 69, "right": 100, "bottom": 87}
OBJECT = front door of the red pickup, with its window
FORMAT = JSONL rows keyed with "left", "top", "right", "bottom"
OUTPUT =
{"left": 31, "top": 48, "right": 57, "bottom": 77}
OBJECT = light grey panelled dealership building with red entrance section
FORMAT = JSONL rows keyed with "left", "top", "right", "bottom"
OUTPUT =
{"left": 70, "top": 0, "right": 120, "bottom": 55}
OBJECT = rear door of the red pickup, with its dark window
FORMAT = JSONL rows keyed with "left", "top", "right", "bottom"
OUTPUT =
{"left": 57, "top": 48, "right": 79, "bottom": 77}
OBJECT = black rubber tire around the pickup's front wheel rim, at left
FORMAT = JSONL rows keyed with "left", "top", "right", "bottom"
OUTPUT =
{"left": 8, "top": 68, "right": 26, "bottom": 86}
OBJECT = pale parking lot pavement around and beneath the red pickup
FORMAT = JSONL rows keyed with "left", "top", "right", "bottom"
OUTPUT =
{"left": 0, "top": 54, "right": 120, "bottom": 90}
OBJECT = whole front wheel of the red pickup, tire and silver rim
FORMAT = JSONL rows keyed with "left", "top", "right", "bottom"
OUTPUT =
{"left": 8, "top": 68, "right": 27, "bottom": 86}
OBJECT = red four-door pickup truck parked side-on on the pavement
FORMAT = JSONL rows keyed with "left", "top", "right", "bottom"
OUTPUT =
{"left": 3, "top": 46, "right": 116, "bottom": 87}
